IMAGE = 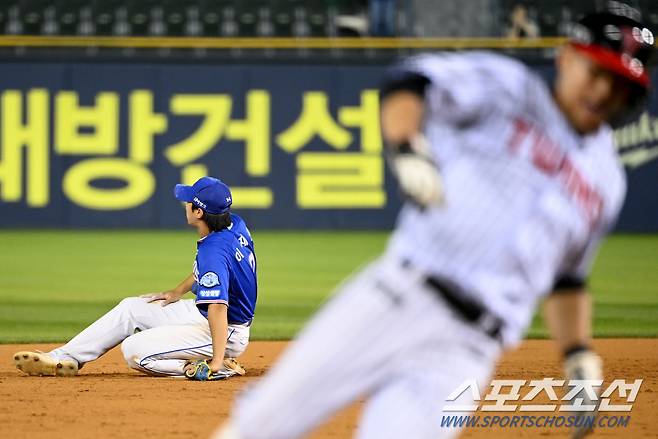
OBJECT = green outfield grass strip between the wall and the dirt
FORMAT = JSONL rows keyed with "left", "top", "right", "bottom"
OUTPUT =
{"left": 0, "top": 231, "right": 658, "bottom": 343}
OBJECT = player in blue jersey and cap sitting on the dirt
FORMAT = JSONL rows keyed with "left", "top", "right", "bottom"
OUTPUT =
{"left": 14, "top": 177, "right": 257, "bottom": 381}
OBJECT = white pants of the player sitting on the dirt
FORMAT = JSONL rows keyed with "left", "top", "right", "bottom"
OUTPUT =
{"left": 50, "top": 297, "right": 249, "bottom": 376}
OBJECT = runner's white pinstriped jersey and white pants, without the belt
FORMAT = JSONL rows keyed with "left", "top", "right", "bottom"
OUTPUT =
{"left": 223, "top": 53, "right": 625, "bottom": 439}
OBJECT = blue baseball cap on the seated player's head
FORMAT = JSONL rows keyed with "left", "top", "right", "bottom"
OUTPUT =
{"left": 174, "top": 177, "right": 233, "bottom": 215}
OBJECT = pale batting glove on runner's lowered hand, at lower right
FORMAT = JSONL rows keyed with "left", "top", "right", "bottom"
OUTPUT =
{"left": 564, "top": 349, "right": 603, "bottom": 439}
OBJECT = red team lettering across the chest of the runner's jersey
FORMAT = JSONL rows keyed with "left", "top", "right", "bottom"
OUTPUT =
{"left": 508, "top": 118, "right": 603, "bottom": 228}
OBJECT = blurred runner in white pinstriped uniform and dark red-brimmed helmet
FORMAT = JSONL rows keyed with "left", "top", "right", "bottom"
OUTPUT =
{"left": 214, "top": 6, "right": 654, "bottom": 439}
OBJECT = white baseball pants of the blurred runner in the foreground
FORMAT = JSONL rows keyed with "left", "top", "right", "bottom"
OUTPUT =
{"left": 223, "top": 259, "right": 502, "bottom": 439}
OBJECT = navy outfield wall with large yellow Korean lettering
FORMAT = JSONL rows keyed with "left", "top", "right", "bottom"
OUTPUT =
{"left": 0, "top": 61, "right": 658, "bottom": 232}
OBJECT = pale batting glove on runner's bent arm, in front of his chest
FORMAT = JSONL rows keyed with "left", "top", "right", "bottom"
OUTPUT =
{"left": 388, "top": 134, "right": 443, "bottom": 207}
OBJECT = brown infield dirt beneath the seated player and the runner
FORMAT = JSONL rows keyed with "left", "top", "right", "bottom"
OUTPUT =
{"left": 0, "top": 339, "right": 658, "bottom": 439}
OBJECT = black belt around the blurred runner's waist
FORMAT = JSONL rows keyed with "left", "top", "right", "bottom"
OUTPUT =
{"left": 402, "top": 261, "right": 505, "bottom": 343}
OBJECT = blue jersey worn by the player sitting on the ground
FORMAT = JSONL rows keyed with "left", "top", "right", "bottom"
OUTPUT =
{"left": 192, "top": 214, "right": 257, "bottom": 324}
